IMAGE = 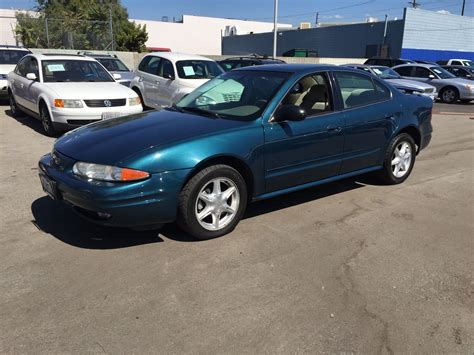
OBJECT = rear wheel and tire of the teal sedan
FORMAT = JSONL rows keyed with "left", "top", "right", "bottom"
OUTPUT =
{"left": 379, "top": 133, "right": 416, "bottom": 185}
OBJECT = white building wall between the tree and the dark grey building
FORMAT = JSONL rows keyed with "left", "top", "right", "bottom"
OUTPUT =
{"left": 131, "top": 15, "right": 291, "bottom": 55}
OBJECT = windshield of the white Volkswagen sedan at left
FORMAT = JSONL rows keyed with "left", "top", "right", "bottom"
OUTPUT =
{"left": 41, "top": 59, "right": 114, "bottom": 83}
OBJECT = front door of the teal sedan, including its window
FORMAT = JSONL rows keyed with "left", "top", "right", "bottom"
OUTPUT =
{"left": 264, "top": 73, "right": 344, "bottom": 192}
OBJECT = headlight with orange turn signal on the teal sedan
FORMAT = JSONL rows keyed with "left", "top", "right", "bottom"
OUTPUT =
{"left": 72, "top": 162, "right": 150, "bottom": 181}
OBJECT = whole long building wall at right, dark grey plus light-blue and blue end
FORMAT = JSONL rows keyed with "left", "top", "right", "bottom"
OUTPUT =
{"left": 222, "top": 8, "right": 474, "bottom": 61}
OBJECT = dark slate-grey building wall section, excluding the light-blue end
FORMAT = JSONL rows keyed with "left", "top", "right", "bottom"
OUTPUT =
{"left": 222, "top": 20, "right": 403, "bottom": 58}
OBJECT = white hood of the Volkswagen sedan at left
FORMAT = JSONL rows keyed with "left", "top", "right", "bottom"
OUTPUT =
{"left": 45, "top": 82, "right": 137, "bottom": 100}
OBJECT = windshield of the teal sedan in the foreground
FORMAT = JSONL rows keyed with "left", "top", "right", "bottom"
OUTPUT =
{"left": 175, "top": 70, "right": 291, "bottom": 120}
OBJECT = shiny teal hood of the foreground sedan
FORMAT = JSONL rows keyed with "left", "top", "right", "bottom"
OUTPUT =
{"left": 54, "top": 110, "right": 249, "bottom": 165}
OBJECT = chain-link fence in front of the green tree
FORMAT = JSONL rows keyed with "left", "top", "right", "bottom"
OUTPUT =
{"left": 14, "top": 14, "right": 115, "bottom": 50}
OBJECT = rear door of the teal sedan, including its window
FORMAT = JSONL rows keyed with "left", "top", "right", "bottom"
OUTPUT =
{"left": 334, "top": 71, "right": 402, "bottom": 174}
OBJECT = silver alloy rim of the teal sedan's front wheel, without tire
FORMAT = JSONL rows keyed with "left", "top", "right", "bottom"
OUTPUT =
{"left": 194, "top": 177, "right": 240, "bottom": 231}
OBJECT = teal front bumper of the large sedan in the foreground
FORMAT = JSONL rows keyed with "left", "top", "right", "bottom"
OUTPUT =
{"left": 39, "top": 152, "right": 189, "bottom": 228}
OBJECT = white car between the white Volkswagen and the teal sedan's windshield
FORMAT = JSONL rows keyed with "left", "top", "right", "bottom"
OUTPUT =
{"left": 130, "top": 52, "right": 224, "bottom": 108}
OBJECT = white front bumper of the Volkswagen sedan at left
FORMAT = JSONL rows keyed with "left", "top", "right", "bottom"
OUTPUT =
{"left": 51, "top": 105, "right": 143, "bottom": 127}
